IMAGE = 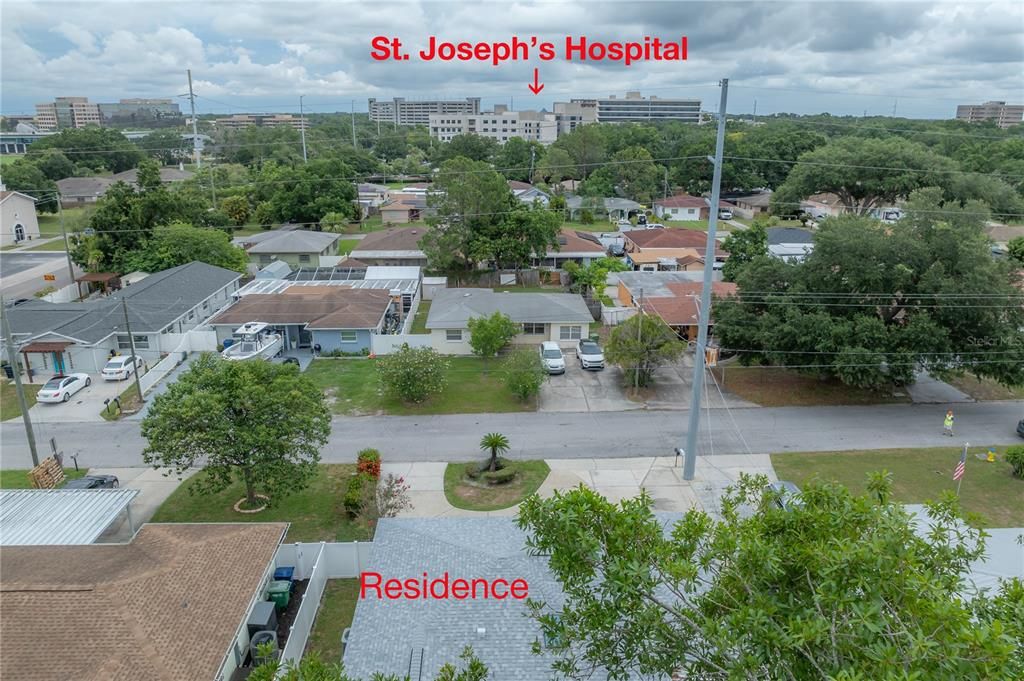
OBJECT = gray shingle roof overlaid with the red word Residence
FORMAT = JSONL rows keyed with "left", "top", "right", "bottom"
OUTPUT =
{"left": 344, "top": 518, "right": 681, "bottom": 681}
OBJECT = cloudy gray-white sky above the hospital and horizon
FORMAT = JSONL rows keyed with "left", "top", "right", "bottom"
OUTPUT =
{"left": 0, "top": 0, "right": 1024, "bottom": 118}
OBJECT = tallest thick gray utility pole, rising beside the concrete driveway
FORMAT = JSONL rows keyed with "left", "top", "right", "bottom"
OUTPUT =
{"left": 683, "top": 78, "right": 729, "bottom": 480}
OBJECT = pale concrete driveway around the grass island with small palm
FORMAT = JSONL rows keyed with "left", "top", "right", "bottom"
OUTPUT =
{"left": 381, "top": 455, "right": 776, "bottom": 518}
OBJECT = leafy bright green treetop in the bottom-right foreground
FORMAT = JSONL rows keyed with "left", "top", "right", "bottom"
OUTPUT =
{"left": 518, "top": 472, "right": 1024, "bottom": 681}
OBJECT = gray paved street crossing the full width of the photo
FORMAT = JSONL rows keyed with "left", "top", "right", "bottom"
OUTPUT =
{"left": 0, "top": 401, "right": 1024, "bottom": 468}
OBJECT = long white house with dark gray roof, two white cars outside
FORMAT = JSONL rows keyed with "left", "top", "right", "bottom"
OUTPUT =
{"left": 4, "top": 261, "right": 242, "bottom": 381}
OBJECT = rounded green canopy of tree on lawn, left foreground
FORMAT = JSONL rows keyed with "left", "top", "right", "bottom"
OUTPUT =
{"left": 141, "top": 353, "right": 331, "bottom": 505}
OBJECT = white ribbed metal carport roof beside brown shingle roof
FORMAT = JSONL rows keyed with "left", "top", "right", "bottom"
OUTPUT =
{"left": 0, "top": 490, "right": 138, "bottom": 546}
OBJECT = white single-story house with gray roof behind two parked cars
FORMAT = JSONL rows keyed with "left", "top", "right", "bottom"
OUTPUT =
{"left": 426, "top": 289, "right": 594, "bottom": 354}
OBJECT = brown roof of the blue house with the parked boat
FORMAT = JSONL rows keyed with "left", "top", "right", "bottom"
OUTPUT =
{"left": 210, "top": 286, "right": 391, "bottom": 329}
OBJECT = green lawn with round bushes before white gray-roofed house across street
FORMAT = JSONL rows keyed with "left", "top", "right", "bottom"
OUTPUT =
{"left": 305, "top": 357, "right": 536, "bottom": 416}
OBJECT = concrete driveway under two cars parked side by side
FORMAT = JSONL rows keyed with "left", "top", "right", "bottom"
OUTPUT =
{"left": 540, "top": 358, "right": 643, "bottom": 412}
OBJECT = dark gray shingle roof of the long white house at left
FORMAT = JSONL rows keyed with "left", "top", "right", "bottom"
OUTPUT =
{"left": 6, "top": 261, "right": 242, "bottom": 343}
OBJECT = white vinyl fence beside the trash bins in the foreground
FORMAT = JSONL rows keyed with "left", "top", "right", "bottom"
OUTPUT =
{"left": 274, "top": 542, "right": 373, "bottom": 667}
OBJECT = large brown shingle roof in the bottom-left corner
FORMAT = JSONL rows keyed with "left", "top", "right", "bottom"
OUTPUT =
{"left": 0, "top": 523, "right": 288, "bottom": 681}
